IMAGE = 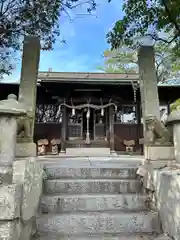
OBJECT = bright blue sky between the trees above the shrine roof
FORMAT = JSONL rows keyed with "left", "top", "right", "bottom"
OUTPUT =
{"left": 4, "top": 0, "right": 123, "bottom": 82}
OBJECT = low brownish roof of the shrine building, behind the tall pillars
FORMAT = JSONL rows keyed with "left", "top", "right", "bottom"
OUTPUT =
{"left": 0, "top": 71, "right": 180, "bottom": 87}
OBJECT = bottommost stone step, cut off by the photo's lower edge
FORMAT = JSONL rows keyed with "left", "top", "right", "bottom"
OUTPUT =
{"left": 32, "top": 234, "right": 159, "bottom": 240}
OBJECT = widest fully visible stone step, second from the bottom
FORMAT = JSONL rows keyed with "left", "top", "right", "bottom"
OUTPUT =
{"left": 36, "top": 211, "right": 160, "bottom": 235}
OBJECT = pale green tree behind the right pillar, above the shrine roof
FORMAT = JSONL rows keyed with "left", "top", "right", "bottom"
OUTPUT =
{"left": 98, "top": 42, "right": 180, "bottom": 82}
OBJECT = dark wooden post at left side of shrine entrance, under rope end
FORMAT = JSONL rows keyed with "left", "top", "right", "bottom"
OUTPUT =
{"left": 61, "top": 106, "right": 67, "bottom": 152}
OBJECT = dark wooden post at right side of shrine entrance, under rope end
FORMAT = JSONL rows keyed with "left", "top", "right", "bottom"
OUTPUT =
{"left": 109, "top": 106, "right": 115, "bottom": 153}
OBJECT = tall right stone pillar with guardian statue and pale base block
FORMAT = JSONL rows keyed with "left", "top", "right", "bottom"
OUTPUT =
{"left": 138, "top": 46, "right": 174, "bottom": 161}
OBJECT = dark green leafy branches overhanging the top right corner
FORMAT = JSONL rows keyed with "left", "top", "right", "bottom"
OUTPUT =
{"left": 107, "top": 0, "right": 180, "bottom": 56}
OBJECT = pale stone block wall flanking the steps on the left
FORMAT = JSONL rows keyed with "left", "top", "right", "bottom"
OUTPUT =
{"left": 0, "top": 158, "right": 43, "bottom": 240}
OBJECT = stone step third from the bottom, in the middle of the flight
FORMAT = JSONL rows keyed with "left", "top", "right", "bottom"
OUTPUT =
{"left": 40, "top": 194, "right": 148, "bottom": 213}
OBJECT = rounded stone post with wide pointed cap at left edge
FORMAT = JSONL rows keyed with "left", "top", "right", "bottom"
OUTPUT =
{"left": 0, "top": 94, "right": 26, "bottom": 184}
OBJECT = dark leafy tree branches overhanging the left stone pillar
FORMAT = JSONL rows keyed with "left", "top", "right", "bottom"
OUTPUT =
{"left": 0, "top": 0, "right": 96, "bottom": 75}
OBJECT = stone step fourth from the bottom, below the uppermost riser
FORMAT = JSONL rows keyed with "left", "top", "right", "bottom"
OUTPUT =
{"left": 43, "top": 179, "right": 141, "bottom": 194}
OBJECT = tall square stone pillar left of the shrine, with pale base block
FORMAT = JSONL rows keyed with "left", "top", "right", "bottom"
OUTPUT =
{"left": 17, "top": 36, "right": 40, "bottom": 157}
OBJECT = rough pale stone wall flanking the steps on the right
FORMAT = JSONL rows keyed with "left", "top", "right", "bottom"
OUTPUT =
{"left": 137, "top": 161, "right": 180, "bottom": 240}
